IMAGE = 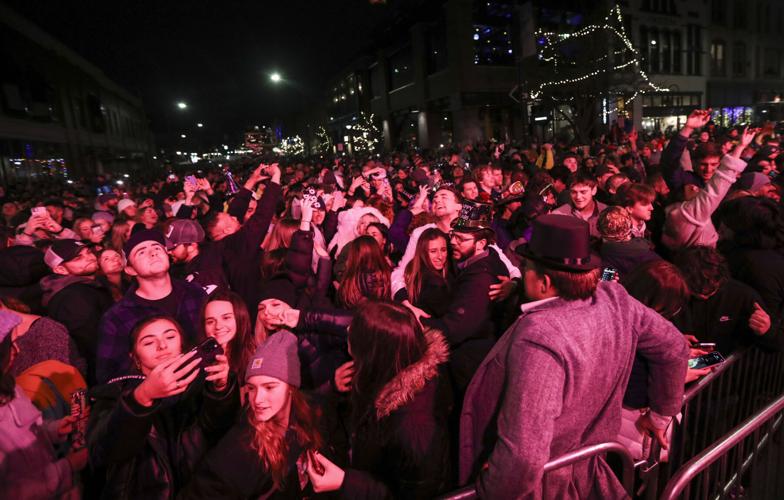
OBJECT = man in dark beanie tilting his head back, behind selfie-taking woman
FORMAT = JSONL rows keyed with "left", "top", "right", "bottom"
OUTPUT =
{"left": 96, "top": 229, "right": 207, "bottom": 383}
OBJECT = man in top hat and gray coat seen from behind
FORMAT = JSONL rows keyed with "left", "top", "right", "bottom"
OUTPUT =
{"left": 460, "top": 214, "right": 689, "bottom": 498}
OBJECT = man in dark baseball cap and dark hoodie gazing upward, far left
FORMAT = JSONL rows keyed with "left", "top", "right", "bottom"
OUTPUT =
{"left": 41, "top": 239, "right": 112, "bottom": 382}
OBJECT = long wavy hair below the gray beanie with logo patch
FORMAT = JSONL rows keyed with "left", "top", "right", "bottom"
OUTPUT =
{"left": 247, "top": 387, "right": 324, "bottom": 489}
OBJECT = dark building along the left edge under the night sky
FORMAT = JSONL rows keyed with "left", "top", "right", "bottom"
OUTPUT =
{"left": 0, "top": 5, "right": 153, "bottom": 182}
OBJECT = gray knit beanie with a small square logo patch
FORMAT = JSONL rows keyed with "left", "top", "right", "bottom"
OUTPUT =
{"left": 245, "top": 331, "right": 300, "bottom": 388}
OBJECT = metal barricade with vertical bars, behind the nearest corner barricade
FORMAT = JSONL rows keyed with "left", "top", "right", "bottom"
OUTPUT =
{"left": 643, "top": 347, "right": 784, "bottom": 499}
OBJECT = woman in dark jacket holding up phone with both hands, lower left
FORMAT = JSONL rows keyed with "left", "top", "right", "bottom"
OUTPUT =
{"left": 88, "top": 316, "right": 239, "bottom": 499}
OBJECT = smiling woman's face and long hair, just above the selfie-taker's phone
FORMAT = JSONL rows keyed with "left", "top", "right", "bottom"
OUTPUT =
{"left": 201, "top": 289, "right": 258, "bottom": 380}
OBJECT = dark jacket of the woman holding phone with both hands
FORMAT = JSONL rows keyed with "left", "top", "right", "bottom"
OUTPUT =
{"left": 88, "top": 378, "right": 239, "bottom": 500}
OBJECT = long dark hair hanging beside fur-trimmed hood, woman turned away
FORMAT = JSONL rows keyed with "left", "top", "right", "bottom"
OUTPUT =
{"left": 348, "top": 300, "right": 427, "bottom": 429}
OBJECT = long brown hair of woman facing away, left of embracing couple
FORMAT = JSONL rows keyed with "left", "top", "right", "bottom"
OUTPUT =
{"left": 338, "top": 236, "right": 392, "bottom": 309}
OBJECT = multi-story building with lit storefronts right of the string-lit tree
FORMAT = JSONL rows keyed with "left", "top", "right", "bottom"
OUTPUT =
{"left": 623, "top": 0, "right": 784, "bottom": 130}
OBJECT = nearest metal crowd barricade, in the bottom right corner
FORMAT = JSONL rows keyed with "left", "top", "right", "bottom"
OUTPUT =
{"left": 661, "top": 396, "right": 784, "bottom": 500}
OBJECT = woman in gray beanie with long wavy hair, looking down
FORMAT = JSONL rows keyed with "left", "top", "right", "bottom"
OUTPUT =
{"left": 180, "top": 332, "right": 330, "bottom": 499}
